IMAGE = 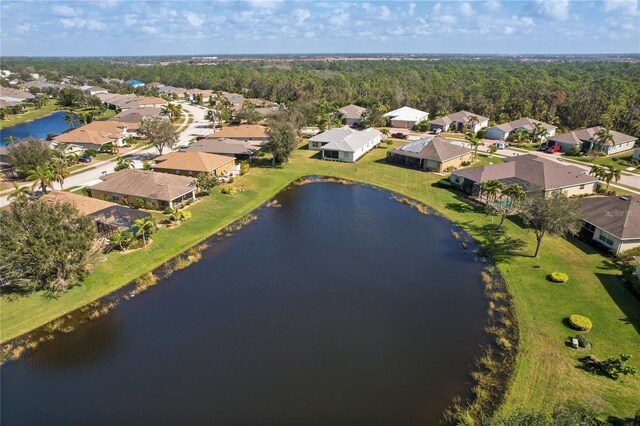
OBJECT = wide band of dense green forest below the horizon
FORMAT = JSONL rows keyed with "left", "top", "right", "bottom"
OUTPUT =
{"left": 3, "top": 59, "right": 640, "bottom": 137}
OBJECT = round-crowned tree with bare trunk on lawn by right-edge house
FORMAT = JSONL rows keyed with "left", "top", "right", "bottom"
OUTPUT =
{"left": 520, "top": 190, "right": 580, "bottom": 257}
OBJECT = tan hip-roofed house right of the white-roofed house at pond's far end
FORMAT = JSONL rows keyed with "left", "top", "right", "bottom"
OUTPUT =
{"left": 387, "top": 136, "right": 473, "bottom": 173}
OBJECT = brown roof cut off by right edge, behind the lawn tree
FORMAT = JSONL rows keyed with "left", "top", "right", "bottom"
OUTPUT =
{"left": 580, "top": 195, "right": 640, "bottom": 240}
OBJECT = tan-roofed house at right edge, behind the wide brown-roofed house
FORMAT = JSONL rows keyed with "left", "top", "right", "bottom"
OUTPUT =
{"left": 547, "top": 126, "right": 638, "bottom": 154}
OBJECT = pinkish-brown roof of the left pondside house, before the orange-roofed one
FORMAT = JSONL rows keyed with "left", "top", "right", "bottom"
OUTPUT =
{"left": 91, "top": 169, "right": 195, "bottom": 201}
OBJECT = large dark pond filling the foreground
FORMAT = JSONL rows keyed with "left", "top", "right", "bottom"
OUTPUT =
{"left": 0, "top": 182, "right": 488, "bottom": 426}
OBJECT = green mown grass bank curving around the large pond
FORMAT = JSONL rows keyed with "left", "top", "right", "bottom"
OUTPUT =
{"left": 0, "top": 144, "right": 640, "bottom": 417}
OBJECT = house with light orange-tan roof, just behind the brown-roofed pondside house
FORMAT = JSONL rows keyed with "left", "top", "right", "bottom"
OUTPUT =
{"left": 153, "top": 151, "right": 236, "bottom": 177}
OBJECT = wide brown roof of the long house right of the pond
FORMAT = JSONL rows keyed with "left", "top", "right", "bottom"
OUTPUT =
{"left": 454, "top": 154, "right": 598, "bottom": 191}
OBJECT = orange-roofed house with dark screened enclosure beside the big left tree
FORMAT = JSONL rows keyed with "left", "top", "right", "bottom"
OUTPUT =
{"left": 38, "top": 191, "right": 150, "bottom": 238}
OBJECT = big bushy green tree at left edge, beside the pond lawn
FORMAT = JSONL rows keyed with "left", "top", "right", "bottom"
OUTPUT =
{"left": 0, "top": 200, "right": 95, "bottom": 293}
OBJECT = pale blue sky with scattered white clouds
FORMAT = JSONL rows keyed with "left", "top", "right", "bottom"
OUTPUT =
{"left": 0, "top": 0, "right": 640, "bottom": 56}
